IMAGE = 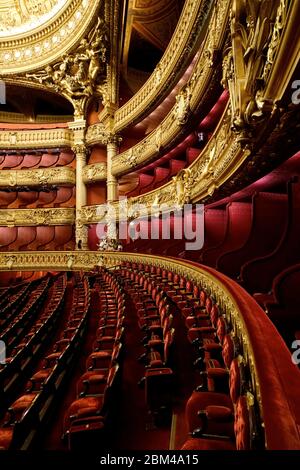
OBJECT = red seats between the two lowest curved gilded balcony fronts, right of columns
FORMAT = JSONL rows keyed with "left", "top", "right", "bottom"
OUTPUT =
{"left": 126, "top": 91, "right": 228, "bottom": 197}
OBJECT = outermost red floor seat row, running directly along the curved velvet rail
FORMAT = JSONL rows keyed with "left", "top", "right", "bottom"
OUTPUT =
{"left": 119, "top": 263, "right": 263, "bottom": 450}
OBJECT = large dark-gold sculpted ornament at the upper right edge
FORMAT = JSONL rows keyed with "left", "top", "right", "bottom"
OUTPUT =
{"left": 222, "top": 0, "right": 292, "bottom": 132}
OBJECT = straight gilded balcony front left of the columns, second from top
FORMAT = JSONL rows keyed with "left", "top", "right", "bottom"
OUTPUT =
{"left": 0, "top": 167, "right": 76, "bottom": 188}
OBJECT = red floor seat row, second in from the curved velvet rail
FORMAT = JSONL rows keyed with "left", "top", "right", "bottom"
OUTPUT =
{"left": 118, "top": 269, "right": 175, "bottom": 413}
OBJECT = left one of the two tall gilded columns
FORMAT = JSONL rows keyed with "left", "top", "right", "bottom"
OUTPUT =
{"left": 69, "top": 120, "right": 88, "bottom": 250}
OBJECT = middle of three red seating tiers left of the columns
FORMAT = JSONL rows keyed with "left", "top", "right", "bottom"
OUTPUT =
{"left": 0, "top": 186, "right": 75, "bottom": 209}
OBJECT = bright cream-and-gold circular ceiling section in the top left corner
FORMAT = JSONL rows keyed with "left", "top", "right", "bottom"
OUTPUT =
{"left": 0, "top": 0, "right": 104, "bottom": 75}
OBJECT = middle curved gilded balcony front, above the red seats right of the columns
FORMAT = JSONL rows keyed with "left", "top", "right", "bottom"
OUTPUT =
{"left": 112, "top": 0, "right": 230, "bottom": 176}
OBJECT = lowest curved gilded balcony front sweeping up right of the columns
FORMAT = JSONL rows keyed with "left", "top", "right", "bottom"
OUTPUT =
{"left": 81, "top": 104, "right": 247, "bottom": 224}
